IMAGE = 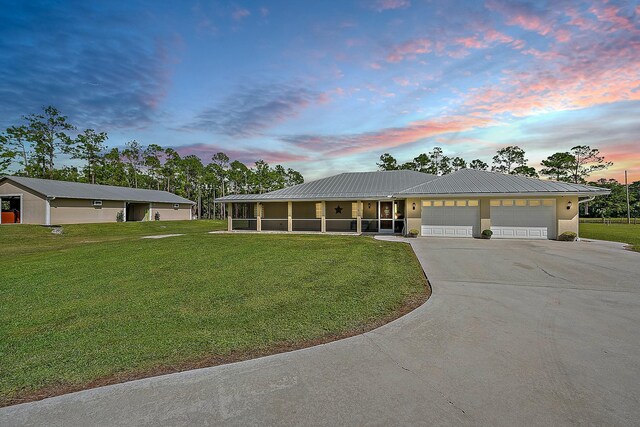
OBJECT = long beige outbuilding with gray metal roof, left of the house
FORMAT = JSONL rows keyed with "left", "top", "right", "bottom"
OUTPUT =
{"left": 0, "top": 176, "right": 194, "bottom": 225}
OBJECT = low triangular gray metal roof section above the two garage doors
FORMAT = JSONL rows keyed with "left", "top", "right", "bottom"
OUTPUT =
{"left": 399, "top": 169, "right": 610, "bottom": 195}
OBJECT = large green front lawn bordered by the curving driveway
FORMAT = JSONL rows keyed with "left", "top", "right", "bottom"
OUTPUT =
{"left": 0, "top": 221, "right": 427, "bottom": 405}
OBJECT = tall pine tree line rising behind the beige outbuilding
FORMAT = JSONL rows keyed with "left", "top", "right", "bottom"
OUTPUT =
{"left": 0, "top": 106, "right": 304, "bottom": 218}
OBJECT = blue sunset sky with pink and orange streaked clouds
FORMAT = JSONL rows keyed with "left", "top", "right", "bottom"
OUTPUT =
{"left": 0, "top": 0, "right": 640, "bottom": 180}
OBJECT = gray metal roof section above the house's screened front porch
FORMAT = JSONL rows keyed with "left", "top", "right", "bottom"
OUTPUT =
{"left": 217, "top": 170, "right": 437, "bottom": 202}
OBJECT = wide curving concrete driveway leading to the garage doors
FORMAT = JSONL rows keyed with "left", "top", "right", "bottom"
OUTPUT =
{"left": 0, "top": 239, "right": 640, "bottom": 426}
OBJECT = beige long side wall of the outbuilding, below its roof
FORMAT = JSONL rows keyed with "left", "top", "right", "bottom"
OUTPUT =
{"left": 51, "top": 199, "right": 124, "bottom": 225}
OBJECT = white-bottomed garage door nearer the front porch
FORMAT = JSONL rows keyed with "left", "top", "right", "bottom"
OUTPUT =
{"left": 421, "top": 200, "right": 480, "bottom": 237}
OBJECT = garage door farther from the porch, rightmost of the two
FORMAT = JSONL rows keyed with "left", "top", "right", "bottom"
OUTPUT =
{"left": 491, "top": 199, "right": 556, "bottom": 239}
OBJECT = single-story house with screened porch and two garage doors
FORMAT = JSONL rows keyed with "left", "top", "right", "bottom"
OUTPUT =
{"left": 217, "top": 169, "right": 609, "bottom": 239}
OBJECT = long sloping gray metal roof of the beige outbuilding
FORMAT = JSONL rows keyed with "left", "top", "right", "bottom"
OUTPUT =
{"left": 0, "top": 176, "right": 194, "bottom": 204}
